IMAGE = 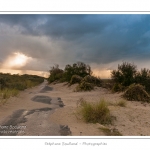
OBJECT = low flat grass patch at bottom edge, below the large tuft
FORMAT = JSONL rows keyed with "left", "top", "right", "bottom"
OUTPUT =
{"left": 100, "top": 127, "right": 122, "bottom": 136}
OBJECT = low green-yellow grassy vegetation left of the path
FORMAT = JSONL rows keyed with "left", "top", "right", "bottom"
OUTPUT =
{"left": 0, "top": 73, "right": 44, "bottom": 102}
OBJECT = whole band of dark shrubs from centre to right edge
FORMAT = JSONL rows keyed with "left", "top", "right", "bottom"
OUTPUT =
{"left": 48, "top": 62, "right": 150, "bottom": 102}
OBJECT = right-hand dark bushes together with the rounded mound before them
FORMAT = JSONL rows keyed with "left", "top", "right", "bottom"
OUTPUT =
{"left": 111, "top": 62, "right": 150, "bottom": 102}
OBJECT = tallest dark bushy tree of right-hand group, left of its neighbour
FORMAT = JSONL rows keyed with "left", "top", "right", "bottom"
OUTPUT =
{"left": 111, "top": 62, "right": 137, "bottom": 86}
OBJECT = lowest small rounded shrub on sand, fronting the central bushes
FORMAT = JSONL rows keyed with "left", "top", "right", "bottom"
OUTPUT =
{"left": 75, "top": 81, "right": 94, "bottom": 92}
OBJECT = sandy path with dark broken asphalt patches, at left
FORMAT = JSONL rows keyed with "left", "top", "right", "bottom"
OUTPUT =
{"left": 0, "top": 81, "right": 70, "bottom": 136}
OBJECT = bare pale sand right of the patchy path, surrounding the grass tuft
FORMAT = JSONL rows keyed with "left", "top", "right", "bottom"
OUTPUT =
{"left": 50, "top": 83, "right": 150, "bottom": 136}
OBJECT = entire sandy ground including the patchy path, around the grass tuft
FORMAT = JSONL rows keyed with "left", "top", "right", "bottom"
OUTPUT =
{"left": 0, "top": 81, "right": 150, "bottom": 136}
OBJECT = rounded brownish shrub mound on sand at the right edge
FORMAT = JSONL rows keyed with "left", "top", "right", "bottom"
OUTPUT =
{"left": 123, "top": 84, "right": 150, "bottom": 102}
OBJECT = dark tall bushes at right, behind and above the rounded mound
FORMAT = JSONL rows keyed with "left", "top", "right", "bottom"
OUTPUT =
{"left": 111, "top": 62, "right": 150, "bottom": 93}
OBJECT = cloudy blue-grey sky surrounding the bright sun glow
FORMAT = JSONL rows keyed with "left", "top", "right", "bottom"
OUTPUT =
{"left": 0, "top": 14, "right": 150, "bottom": 77}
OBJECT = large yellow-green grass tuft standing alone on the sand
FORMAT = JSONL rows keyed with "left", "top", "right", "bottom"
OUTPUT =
{"left": 79, "top": 99, "right": 112, "bottom": 124}
